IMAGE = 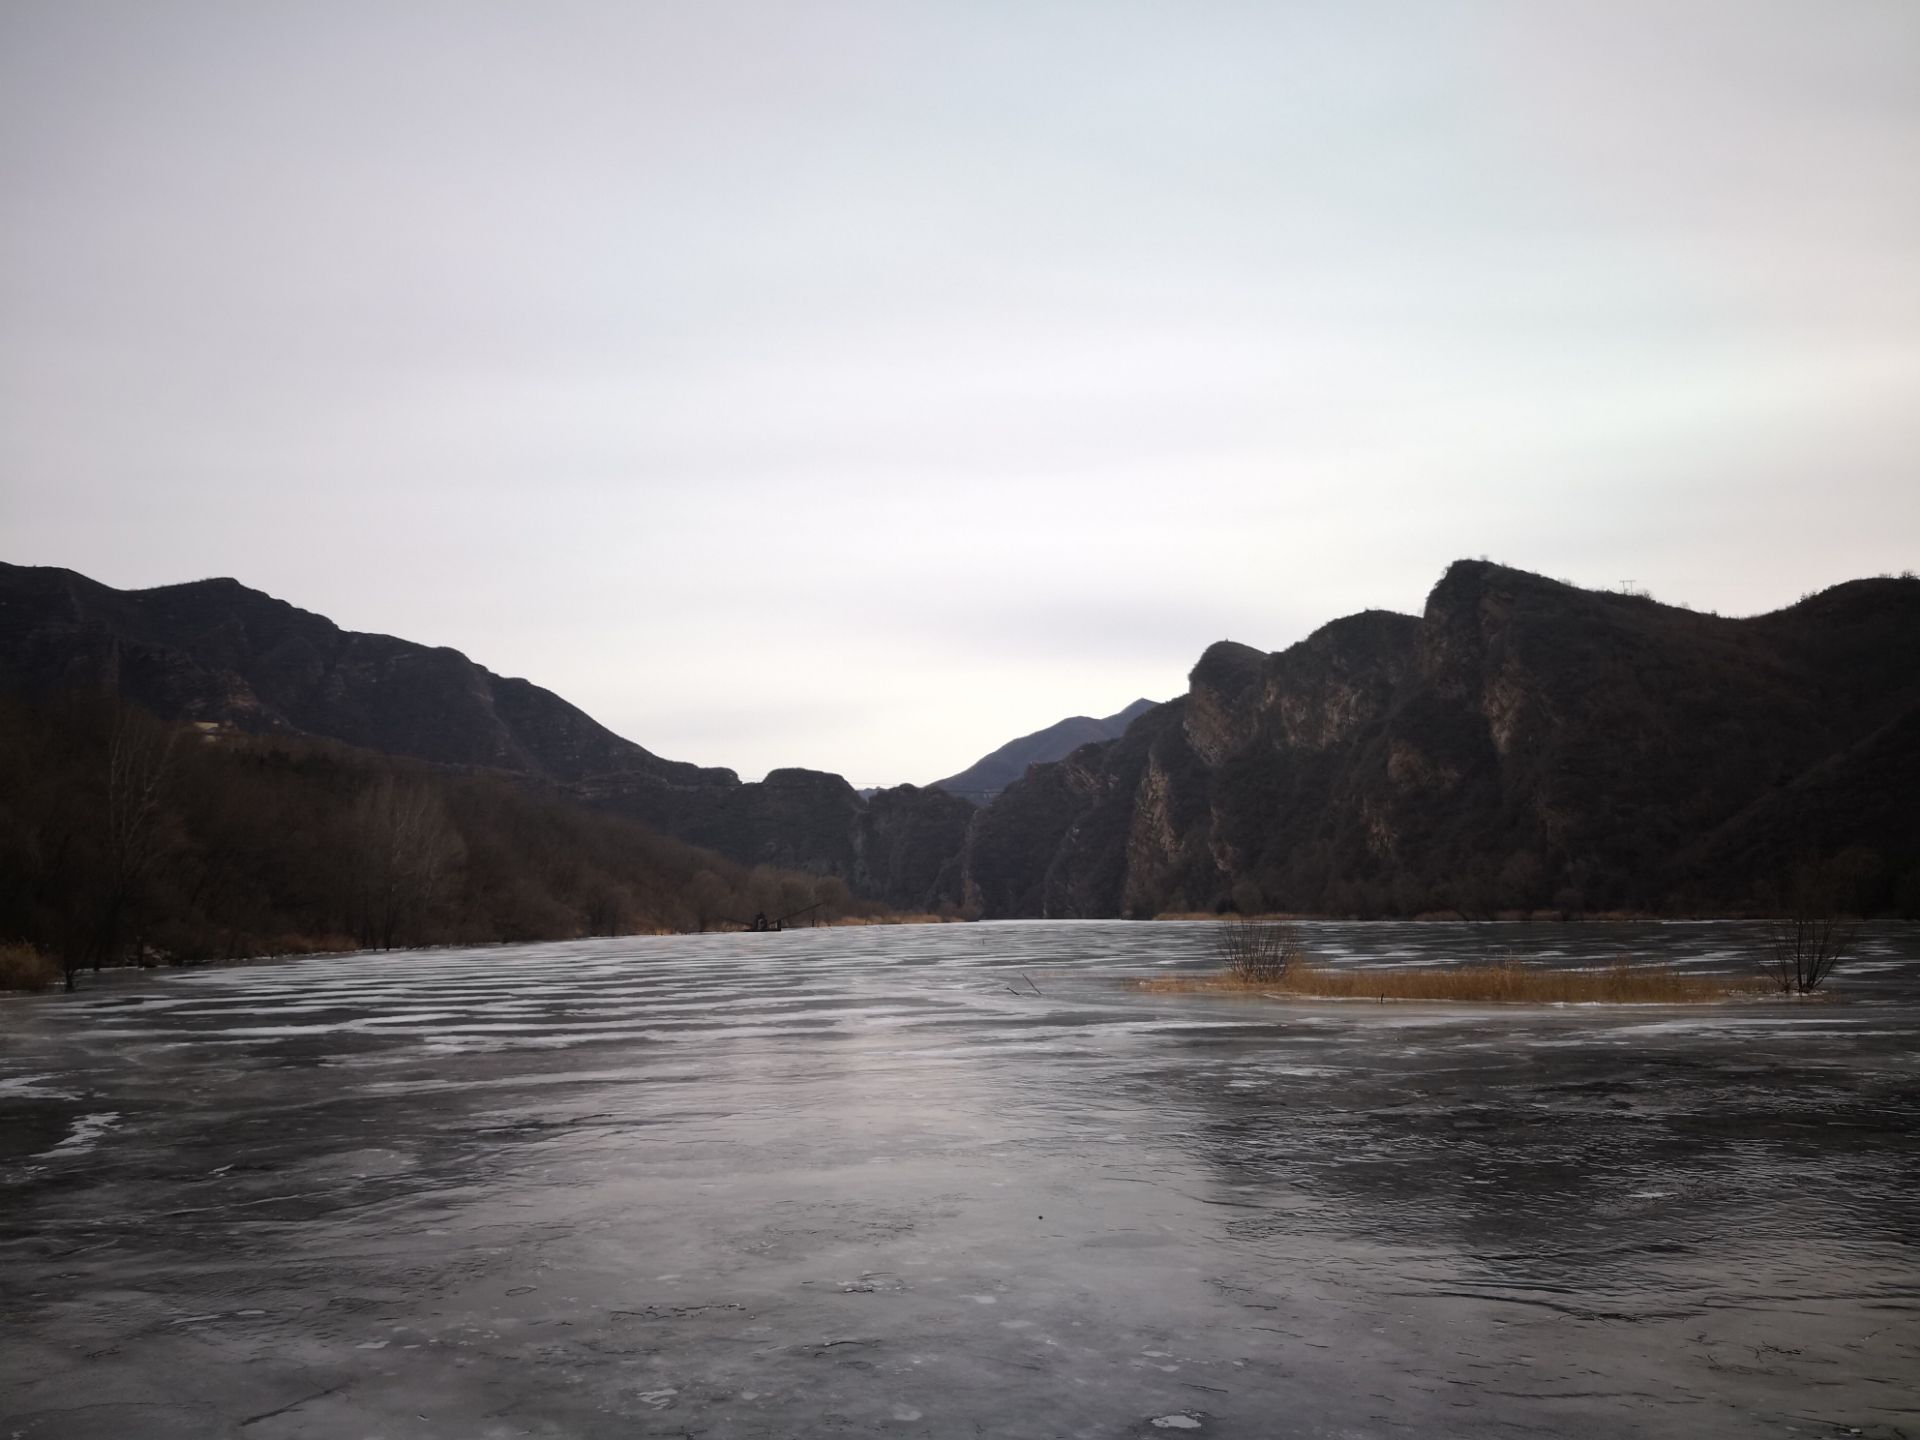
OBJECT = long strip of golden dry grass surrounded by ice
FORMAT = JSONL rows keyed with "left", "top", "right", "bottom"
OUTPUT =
{"left": 1139, "top": 960, "right": 1768, "bottom": 1004}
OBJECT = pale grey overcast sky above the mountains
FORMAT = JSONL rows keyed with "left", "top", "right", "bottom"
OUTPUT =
{"left": 0, "top": 0, "right": 1920, "bottom": 783}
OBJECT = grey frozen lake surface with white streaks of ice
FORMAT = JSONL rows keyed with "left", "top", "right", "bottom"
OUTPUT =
{"left": 0, "top": 922, "right": 1920, "bottom": 1440}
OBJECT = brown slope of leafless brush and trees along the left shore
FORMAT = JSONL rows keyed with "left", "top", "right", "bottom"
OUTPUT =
{"left": 0, "top": 691, "right": 894, "bottom": 983}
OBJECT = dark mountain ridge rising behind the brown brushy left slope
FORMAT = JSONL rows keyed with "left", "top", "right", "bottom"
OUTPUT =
{"left": 0, "top": 564, "right": 973, "bottom": 910}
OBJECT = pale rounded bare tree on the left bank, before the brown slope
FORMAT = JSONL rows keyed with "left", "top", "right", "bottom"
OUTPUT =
{"left": 351, "top": 776, "right": 465, "bottom": 950}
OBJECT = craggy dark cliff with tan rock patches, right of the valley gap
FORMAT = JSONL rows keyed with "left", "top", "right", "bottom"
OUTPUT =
{"left": 964, "top": 563, "right": 1920, "bottom": 916}
